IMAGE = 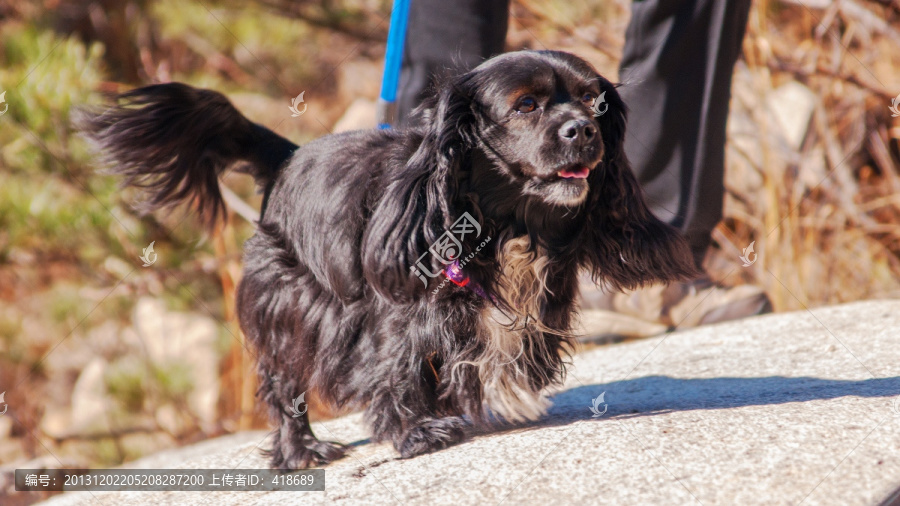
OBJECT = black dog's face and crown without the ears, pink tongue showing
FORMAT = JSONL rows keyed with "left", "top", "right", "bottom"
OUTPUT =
{"left": 458, "top": 51, "right": 624, "bottom": 207}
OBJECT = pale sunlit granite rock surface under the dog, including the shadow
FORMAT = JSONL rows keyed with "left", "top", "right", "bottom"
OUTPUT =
{"left": 38, "top": 301, "right": 900, "bottom": 506}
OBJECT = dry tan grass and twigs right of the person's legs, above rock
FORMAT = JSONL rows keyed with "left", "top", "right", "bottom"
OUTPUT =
{"left": 716, "top": 1, "right": 900, "bottom": 310}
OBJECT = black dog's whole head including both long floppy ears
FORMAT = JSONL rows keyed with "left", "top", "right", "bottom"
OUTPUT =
{"left": 364, "top": 51, "right": 694, "bottom": 299}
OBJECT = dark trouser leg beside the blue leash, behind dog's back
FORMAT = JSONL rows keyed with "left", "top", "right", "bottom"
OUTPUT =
{"left": 397, "top": 0, "right": 509, "bottom": 125}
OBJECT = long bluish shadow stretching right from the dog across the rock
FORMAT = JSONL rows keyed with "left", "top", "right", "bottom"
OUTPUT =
{"left": 473, "top": 376, "right": 900, "bottom": 435}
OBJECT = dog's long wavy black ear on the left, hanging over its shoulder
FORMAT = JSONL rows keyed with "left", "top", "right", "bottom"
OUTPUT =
{"left": 362, "top": 74, "right": 473, "bottom": 302}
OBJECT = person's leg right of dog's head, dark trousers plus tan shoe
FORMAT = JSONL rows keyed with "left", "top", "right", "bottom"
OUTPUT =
{"left": 581, "top": 0, "right": 771, "bottom": 336}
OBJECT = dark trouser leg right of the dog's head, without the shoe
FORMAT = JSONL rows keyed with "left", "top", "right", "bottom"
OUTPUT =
{"left": 619, "top": 0, "right": 751, "bottom": 266}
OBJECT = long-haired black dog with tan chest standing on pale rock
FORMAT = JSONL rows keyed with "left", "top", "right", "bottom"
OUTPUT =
{"left": 81, "top": 51, "right": 695, "bottom": 469}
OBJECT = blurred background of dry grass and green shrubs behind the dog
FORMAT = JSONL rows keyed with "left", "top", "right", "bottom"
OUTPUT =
{"left": 0, "top": 0, "right": 900, "bottom": 504}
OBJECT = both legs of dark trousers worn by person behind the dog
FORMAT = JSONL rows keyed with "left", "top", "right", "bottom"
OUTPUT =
{"left": 398, "top": 0, "right": 750, "bottom": 265}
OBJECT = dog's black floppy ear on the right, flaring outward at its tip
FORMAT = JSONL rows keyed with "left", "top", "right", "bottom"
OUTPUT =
{"left": 583, "top": 78, "right": 698, "bottom": 289}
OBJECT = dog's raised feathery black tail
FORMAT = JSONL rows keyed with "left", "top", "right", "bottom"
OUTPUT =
{"left": 76, "top": 83, "right": 297, "bottom": 226}
